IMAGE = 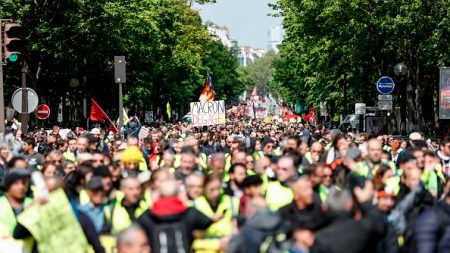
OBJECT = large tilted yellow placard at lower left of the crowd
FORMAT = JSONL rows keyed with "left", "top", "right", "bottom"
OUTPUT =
{"left": 17, "top": 189, "right": 88, "bottom": 253}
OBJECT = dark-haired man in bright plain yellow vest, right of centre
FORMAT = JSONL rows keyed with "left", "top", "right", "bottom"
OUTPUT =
{"left": 266, "top": 156, "right": 297, "bottom": 211}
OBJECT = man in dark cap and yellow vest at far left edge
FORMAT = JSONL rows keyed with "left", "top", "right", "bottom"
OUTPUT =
{"left": 0, "top": 169, "right": 33, "bottom": 252}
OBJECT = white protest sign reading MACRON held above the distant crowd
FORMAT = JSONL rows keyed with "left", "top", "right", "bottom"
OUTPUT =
{"left": 190, "top": 100, "right": 225, "bottom": 126}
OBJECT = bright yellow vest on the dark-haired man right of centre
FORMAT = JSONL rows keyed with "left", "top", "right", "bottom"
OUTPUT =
{"left": 266, "top": 181, "right": 294, "bottom": 211}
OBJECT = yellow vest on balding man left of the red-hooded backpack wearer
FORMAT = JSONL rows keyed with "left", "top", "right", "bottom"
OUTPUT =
{"left": 105, "top": 200, "right": 148, "bottom": 235}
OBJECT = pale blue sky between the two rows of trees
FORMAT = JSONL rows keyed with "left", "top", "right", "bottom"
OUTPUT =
{"left": 193, "top": 0, "right": 281, "bottom": 49}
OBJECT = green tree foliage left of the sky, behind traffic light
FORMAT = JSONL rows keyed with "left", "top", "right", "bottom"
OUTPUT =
{"left": 0, "top": 0, "right": 246, "bottom": 123}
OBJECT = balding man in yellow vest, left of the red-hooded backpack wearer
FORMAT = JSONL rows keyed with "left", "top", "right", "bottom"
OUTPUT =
{"left": 105, "top": 177, "right": 148, "bottom": 234}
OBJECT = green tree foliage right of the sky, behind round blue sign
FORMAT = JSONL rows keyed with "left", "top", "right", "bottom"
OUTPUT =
{"left": 275, "top": 0, "right": 450, "bottom": 130}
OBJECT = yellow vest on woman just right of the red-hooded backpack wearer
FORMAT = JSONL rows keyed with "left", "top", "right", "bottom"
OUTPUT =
{"left": 193, "top": 195, "right": 239, "bottom": 238}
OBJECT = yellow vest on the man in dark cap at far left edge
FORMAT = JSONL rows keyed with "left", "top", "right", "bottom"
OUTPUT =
{"left": 0, "top": 196, "right": 34, "bottom": 252}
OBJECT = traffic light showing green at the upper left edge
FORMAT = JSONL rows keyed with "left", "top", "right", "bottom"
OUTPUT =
{"left": 3, "top": 23, "right": 25, "bottom": 63}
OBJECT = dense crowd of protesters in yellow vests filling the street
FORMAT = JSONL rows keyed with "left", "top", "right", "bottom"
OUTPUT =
{"left": 0, "top": 118, "right": 450, "bottom": 253}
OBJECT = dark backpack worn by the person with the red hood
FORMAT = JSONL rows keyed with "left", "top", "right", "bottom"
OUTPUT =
{"left": 151, "top": 221, "right": 190, "bottom": 253}
